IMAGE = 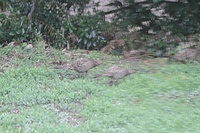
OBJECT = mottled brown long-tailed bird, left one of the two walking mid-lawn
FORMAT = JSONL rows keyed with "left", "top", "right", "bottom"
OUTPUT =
{"left": 55, "top": 58, "right": 102, "bottom": 73}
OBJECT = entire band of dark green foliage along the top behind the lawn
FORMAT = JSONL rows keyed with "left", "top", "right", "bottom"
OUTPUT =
{"left": 0, "top": 0, "right": 200, "bottom": 49}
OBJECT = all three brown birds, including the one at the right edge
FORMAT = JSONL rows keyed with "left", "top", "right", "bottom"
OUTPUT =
{"left": 52, "top": 46, "right": 200, "bottom": 80}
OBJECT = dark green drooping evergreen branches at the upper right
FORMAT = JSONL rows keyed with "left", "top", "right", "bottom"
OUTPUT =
{"left": 108, "top": 0, "right": 200, "bottom": 34}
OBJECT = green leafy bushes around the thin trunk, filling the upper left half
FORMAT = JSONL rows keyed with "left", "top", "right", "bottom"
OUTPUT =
{"left": 0, "top": 0, "right": 105, "bottom": 49}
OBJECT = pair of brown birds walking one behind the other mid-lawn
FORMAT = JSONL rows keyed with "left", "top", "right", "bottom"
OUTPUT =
{"left": 55, "top": 58, "right": 133, "bottom": 80}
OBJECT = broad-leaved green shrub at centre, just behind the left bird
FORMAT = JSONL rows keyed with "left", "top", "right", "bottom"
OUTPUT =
{"left": 70, "top": 15, "right": 106, "bottom": 50}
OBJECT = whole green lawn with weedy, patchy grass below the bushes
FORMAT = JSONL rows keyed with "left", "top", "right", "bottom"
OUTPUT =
{"left": 0, "top": 43, "right": 200, "bottom": 133}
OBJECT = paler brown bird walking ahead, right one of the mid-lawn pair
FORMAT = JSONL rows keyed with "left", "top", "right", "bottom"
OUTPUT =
{"left": 95, "top": 66, "right": 133, "bottom": 79}
